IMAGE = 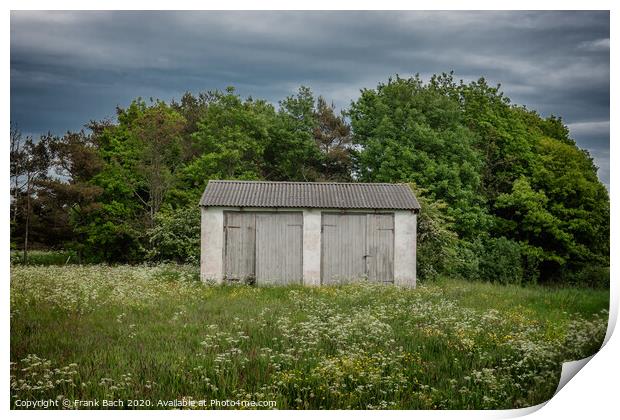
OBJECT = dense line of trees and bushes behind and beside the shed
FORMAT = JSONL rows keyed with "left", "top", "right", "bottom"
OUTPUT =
{"left": 11, "top": 74, "right": 609, "bottom": 284}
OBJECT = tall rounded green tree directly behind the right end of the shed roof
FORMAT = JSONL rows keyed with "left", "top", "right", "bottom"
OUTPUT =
{"left": 349, "top": 76, "right": 489, "bottom": 238}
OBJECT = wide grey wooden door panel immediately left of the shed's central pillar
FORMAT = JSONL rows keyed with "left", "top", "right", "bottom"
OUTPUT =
{"left": 256, "top": 212, "right": 303, "bottom": 284}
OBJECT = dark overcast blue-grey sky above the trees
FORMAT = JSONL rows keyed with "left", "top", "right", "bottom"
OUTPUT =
{"left": 11, "top": 11, "right": 609, "bottom": 186}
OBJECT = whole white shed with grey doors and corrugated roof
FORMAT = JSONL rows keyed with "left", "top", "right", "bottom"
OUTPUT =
{"left": 200, "top": 181, "right": 420, "bottom": 287}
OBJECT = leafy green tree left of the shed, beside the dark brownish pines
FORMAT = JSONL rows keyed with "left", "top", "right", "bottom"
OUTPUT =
{"left": 79, "top": 99, "right": 185, "bottom": 261}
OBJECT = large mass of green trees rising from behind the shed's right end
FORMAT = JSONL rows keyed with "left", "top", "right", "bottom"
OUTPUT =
{"left": 349, "top": 74, "right": 609, "bottom": 283}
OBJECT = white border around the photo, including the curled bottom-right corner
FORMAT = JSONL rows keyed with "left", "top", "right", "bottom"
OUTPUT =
{"left": 0, "top": 0, "right": 620, "bottom": 419}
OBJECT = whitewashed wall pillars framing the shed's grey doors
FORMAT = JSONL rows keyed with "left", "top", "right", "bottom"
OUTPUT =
{"left": 200, "top": 207, "right": 417, "bottom": 287}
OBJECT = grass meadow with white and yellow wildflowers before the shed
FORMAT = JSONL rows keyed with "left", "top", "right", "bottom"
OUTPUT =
{"left": 11, "top": 266, "right": 609, "bottom": 409}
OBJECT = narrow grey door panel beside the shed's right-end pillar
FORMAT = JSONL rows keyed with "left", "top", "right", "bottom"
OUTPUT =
{"left": 366, "top": 214, "right": 394, "bottom": 283}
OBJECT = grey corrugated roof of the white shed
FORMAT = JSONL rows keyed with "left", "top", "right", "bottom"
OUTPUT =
{"left": 200, "top": 181, "right": 420, "bottom": 210}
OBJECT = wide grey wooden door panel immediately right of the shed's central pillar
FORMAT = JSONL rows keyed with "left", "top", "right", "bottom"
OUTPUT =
{"left": 321, "top": 213, "right": 366, "bottom": 284}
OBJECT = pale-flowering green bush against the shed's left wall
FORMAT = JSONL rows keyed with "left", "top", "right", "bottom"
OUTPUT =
{"left": 147, "top": 207, "right": 200, "bottom": 264}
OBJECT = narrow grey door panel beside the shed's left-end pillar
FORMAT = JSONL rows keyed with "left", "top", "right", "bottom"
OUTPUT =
{"left": 224, "top": 212, "right": 256, "bottom": 281}
